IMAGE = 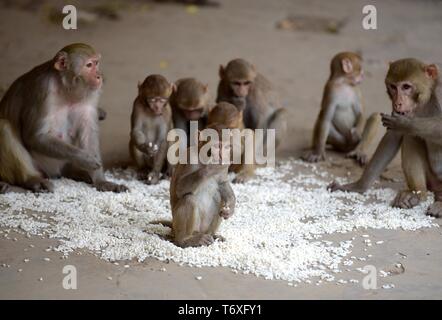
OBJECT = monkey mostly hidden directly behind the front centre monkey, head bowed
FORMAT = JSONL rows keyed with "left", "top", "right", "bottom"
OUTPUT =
{"left": 208, "top": 102, "right": 255, "bottom": 183}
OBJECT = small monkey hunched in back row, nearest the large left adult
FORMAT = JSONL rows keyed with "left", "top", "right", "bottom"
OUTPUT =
{"left": 129, "top": 75, "right": 174, "bottom": 184}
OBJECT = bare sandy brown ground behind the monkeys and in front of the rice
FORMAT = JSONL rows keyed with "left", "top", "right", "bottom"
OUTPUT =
{"left": 0, "top": 0, "right": 442, "bottom": 299}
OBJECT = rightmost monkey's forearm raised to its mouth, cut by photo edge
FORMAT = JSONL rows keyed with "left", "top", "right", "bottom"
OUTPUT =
{"left": 382, "top": 114, "right": 442, "bottom": 145}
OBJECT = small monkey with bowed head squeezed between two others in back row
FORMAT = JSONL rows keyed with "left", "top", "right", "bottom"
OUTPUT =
{"left": 170, "top": 78, "right": 210, "bottom": 145}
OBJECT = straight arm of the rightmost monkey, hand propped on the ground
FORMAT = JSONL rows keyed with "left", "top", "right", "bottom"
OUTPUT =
{"left": 328, "top": 130, "right": 403, "bottom": 193}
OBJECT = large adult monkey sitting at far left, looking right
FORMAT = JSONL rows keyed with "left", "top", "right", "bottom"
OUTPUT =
{"left": 0, "top": 43, "right": 127, "bottom": 192}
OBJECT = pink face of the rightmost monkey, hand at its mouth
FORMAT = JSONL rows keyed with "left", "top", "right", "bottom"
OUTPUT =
{"left": 387, "top": 81, "right": 417, "bottom": 115}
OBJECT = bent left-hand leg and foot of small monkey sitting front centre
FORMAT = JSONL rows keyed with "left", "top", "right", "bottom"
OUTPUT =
{"left": 172, "top": 194, "right": 214, "bottom": 248}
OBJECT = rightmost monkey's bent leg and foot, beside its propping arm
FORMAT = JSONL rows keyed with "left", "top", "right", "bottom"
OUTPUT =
{"left": 393, "top": 136, "right": 428, "bottom": 208}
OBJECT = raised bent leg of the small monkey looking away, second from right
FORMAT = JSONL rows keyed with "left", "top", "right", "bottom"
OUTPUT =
{"left": 347, "top": 112, "right": 381, "bottom": 165}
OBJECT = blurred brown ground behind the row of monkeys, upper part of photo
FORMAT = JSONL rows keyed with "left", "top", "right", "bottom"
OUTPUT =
{"left": 0, "top": 0, "right": 442, "bottom": 166}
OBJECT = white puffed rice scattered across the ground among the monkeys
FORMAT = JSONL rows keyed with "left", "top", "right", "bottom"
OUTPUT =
{"left": 0, "top": 160, "right": 434, "bottom": 284}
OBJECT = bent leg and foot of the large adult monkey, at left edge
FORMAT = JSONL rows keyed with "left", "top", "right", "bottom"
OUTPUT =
{"left": 0, "top": 119, "right": 53, "bottom": 192}
